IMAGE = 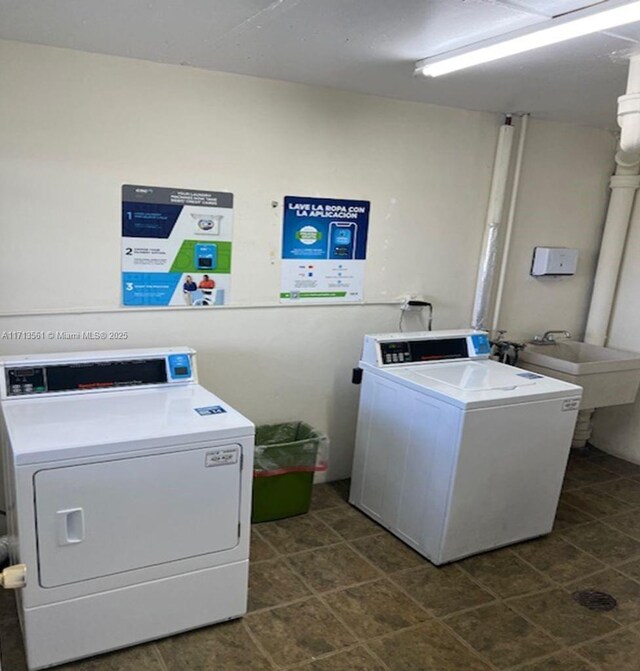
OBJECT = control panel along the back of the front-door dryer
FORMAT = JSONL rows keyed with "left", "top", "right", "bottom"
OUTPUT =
{"left": 0, "top": 348, "right": 196, "bottom": 398}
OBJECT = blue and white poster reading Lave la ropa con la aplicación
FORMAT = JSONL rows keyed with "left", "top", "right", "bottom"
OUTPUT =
{"left": 280, "top": 196, "right": 371, "bottom": 303}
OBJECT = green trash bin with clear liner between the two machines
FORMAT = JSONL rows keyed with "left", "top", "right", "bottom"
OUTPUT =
{"left": 251, "top": 422, "right": 327, "bottom": 523}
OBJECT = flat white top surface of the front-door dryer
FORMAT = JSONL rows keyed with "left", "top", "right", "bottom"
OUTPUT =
{"left": 2, "top": 384, "right": 255, "bottom": 464}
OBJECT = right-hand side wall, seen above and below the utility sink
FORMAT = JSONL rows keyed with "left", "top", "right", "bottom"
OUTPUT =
{"left": 591, "top": 197, "right": 640, "bottom": 464}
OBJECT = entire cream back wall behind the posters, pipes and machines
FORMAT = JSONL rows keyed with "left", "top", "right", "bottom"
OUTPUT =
{"left": 0, "top": 42, "right": 613, "bottom": 477}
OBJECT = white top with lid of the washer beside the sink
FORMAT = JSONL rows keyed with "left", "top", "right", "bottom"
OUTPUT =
{"left": 362, "top": 360, "right": 582, "bottom": 409}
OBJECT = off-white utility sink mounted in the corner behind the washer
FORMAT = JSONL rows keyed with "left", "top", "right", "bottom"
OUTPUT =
{"left": 519, "top": 340, "right": 640, "bottom": 409}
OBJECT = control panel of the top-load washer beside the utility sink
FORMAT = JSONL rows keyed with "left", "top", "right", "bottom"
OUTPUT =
{"left": 362, "top": 331, "right": 491, "bottom": 367}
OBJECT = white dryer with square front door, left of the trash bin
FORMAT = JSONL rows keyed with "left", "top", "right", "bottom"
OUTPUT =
{"left": 0, "top": 348, "right": 255, "bottom": 669}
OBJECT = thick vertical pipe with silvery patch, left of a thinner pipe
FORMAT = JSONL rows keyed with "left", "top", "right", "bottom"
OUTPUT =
{"left": 471, "top": 116, "right": 514, "bottom": 330}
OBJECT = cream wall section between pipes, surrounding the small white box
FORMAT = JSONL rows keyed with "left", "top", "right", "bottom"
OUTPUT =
{"left": 492, "top": 117, "right": 615, "bottom": 340}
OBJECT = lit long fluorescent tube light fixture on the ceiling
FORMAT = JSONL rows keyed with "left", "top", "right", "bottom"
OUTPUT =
{"left": 415, "top": 2, "right": 640, "bottom": 77}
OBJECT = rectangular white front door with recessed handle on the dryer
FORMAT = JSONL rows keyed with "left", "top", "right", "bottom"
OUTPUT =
{"left": 34, "top": 445, "right": 242, "bottom": 587}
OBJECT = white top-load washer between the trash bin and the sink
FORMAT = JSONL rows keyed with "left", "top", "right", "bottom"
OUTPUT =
{"left": 350, "top": 331, "right": 582, "bottom": 564}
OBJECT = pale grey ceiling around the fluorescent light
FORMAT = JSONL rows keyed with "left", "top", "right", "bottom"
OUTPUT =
{"left": 0, "top": 0, "right": 640, "bottom": 128}
